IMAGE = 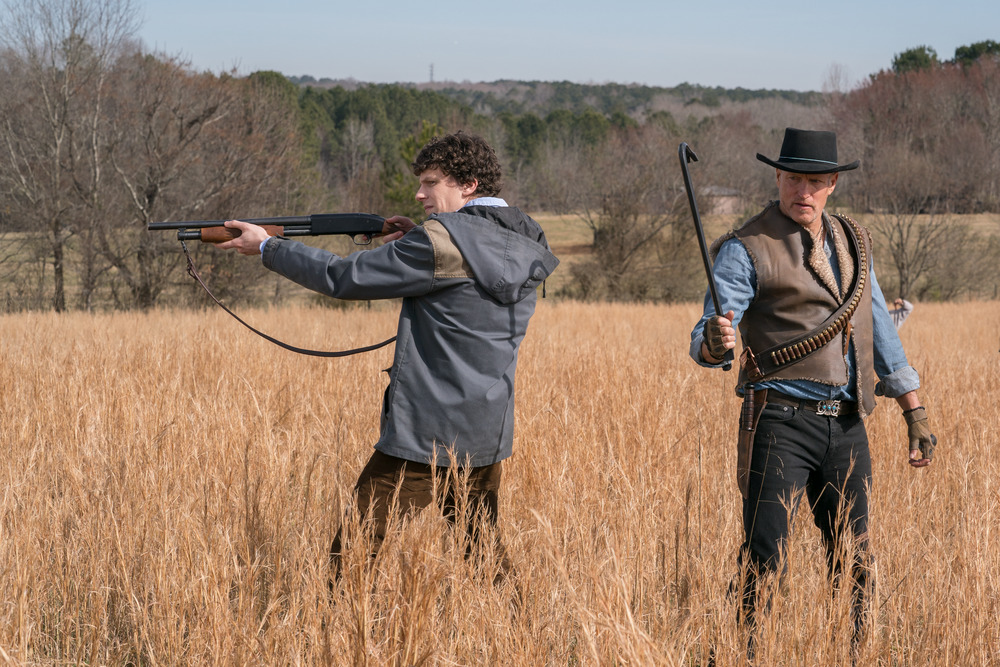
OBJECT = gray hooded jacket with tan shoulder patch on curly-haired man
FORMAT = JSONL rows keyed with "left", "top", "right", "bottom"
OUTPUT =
{"left": 263, "top": 206, "right": 559, "bottom": 467}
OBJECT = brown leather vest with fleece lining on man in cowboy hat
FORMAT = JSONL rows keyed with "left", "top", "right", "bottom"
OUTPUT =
{"left": 716, "top": 202, "right": 875, "bottom": 416}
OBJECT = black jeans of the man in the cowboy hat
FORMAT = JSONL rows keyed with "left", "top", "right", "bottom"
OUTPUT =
{"left": 740, "top": 403, "right": 872, "bottom": 633}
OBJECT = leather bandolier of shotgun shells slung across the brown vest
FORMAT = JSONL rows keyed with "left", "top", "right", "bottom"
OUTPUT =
{"left": 744, "top": 214, "right": 868, "bottom": 382}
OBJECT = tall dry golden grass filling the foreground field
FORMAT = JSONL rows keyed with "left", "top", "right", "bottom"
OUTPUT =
{"left": 0, "top": 300, "right": 1000, "bottom": 665}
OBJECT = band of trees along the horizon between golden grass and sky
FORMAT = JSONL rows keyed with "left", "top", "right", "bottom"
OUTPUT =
{"left": 0, "top": 0, "right": 1000, "bottom": 311}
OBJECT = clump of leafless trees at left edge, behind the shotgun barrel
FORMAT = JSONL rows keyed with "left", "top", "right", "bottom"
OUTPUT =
{"left": 0, "top": 0, "right": 319, "bottom": 310}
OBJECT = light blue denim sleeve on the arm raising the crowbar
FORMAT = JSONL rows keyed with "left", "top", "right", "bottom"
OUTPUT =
{"left": 689, "top": 238, "right": 757, "bottom": 368}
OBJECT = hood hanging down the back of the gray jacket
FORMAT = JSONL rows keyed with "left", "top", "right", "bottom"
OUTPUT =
{"left": 431, "top": 206, "right": 559, "bottom": 304}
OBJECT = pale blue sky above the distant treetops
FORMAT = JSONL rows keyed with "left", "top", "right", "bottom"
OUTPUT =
{"left": 137, "top": 0, "right": 1000, "bottom": 90}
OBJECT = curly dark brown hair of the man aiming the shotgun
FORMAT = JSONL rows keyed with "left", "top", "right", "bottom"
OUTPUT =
{"left": 411, "top": 132, "right": 503, "bottom": 197}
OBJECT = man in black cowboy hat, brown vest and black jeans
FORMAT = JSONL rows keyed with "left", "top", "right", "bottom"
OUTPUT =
{"left": 691, "top": 128, "right": 936, "bottom": 646}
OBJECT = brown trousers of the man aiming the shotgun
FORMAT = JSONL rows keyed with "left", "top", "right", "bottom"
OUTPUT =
{"left": 330, "top": 450, "right": 511, "bottom": 583}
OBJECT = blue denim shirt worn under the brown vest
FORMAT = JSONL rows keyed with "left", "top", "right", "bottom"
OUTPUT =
{"left": 690, "top": 226, "right": 920, "bottom": 401}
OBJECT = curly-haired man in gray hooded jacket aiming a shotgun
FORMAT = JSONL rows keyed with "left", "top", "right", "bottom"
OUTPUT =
{"left": 218, "top": 132, "right": 559, "bottom": 580}
